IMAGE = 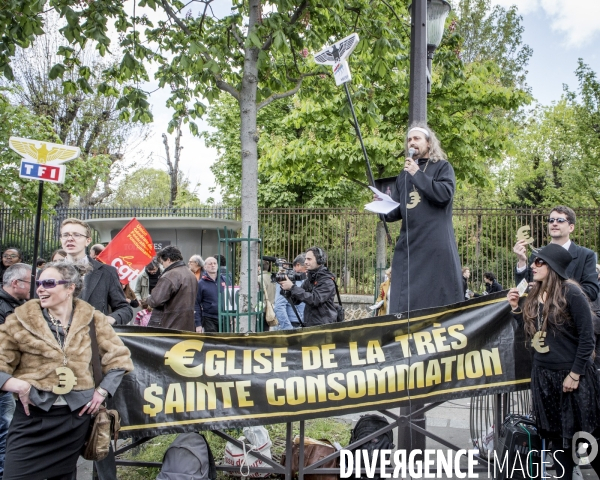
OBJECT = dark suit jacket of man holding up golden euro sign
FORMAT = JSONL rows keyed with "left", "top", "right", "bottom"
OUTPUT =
{"left": 515, "top": 242, "right": 600, "bottom": 302}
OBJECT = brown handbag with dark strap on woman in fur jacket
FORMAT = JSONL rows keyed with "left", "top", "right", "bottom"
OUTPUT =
{"left": 81, "top": 319, "right": 121, "bottom": 461}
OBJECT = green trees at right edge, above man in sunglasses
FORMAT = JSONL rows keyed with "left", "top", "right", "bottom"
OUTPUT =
{"left": 498, "top": 59, "right": 600, "bottom": 208}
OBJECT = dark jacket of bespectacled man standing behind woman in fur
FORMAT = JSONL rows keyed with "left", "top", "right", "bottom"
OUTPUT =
{"left": 79, "top": 257, "right": 133, "bottom": 325}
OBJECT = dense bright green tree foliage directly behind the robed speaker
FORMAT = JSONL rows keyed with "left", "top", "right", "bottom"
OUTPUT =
{"left": 206, "top": 0, "right": 530, "bottom": 207}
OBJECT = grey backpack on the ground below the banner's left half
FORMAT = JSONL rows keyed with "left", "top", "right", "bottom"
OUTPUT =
{"left": 156, "top": 432, "right": 217, "bottom": 480}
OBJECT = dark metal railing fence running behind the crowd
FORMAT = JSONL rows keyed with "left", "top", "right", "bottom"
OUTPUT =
{"left": 0, "top": 206, "right": 600, "bottom": 295}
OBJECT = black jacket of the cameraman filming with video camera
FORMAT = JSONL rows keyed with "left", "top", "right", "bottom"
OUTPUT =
{"left": 281, "top": 266, "right": 337, "bottom": 327}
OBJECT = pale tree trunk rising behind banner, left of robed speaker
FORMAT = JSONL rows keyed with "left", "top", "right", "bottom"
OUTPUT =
{"left": 240, "top": 0, "right": 260, "bottom": 331}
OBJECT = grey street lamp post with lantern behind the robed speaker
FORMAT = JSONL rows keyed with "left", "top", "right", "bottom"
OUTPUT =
{"left": 398, "top": 0, "right": 451, "bottom": 458}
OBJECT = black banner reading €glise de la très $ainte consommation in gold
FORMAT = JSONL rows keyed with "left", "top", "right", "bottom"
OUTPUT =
{"left": 112, "top": 292, "right": 531, "bottom": 436}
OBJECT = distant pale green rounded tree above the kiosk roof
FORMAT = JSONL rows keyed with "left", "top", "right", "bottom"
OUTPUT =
{"left": 108, "top": 168, "right": 201, "bottom": 208}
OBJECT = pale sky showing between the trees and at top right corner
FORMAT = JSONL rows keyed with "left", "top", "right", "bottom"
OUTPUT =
{"left": 136, "top": 0, "right": 600, "bottom": 203}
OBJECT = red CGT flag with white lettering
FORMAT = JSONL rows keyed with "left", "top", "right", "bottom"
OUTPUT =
{"left": 96, "top": 218, "right": 156, "bottom": 285}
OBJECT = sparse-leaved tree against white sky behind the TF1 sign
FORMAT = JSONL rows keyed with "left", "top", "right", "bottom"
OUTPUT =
{"left": 6, "top": 15, "right": 150, "bottom": 206}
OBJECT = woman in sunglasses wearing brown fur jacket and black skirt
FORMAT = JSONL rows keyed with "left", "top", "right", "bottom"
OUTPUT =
{"left": 0, "top": 262, "right": 133, "bottom": 480}
